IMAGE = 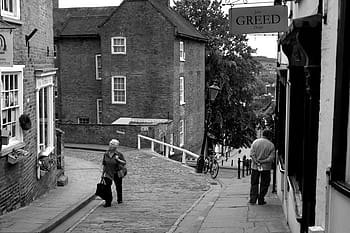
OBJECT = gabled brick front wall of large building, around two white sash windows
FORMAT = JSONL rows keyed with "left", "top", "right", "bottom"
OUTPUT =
{"left": 101, "top": 1, "right": 174, "bottom": 123}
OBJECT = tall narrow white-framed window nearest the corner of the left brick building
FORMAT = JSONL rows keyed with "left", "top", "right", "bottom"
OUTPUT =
{"left": 36, "top": 71, "right": 56, "bottom": 156}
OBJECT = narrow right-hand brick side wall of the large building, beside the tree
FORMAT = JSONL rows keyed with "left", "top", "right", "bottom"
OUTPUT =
{"left": 173, "top": 38, "right": 205, "bottom": 153}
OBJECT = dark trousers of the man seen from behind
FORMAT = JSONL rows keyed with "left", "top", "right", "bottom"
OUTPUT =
{"left": 249, "top": 169, "right": 271, "bottom": 203}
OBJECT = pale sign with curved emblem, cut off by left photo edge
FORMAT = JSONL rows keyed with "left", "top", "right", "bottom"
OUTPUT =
{"left": 0, "top": 28, "right": 13, "bottom": 67}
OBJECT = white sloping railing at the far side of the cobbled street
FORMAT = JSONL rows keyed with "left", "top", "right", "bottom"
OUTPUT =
{"left": 137, "top": 134, "right": 199, "bottom": 164}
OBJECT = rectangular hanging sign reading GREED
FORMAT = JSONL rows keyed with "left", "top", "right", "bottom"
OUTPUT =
{"left": 229, "top": 5, "right": 288, "bottom": 34}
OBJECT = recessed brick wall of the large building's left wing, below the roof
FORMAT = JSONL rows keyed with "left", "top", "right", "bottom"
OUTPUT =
{"left": 57, "top": 38, "right": 101, "bottom": 123}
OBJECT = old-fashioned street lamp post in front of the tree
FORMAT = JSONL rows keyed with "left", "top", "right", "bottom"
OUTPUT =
{"left": 197, "top": 80, "right": 221, "bottom": 173}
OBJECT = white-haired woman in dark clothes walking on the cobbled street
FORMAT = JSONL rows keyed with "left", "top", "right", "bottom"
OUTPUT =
{"left": 102, "top": 139, "right": 126, "bottom": 207}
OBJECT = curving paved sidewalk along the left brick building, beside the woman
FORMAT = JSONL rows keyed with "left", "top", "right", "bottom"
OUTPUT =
{"left": 0, "top": 156, "right": 101, "bottom": 233}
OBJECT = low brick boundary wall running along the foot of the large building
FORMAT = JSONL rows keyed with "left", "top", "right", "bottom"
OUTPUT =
{"left": 60, "top": 124, "right": 156, "bottom": 148}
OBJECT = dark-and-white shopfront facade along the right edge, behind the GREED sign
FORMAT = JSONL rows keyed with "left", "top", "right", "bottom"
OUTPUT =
{"left": 275, "top": 0, "right": 350, "bottom": 233}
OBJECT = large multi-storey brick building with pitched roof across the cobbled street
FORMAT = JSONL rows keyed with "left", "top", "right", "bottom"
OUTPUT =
{"left": 54, "top": 0, "right": 206, "bottom": 152}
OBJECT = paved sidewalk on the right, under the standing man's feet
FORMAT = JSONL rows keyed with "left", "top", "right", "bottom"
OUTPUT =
{"left": 172, "top": 176, "right": 290, "bottom": 233}
